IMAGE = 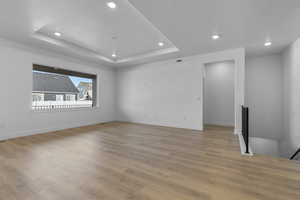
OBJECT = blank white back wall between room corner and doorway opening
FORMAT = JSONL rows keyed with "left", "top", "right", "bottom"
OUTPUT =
{"left": 117, "top": 57, "right": 202, "bottom": 130}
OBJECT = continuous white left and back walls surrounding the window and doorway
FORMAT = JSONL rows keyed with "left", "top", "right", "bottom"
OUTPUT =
{"left": 0, "top": 40, "right": 244, "bottom": 139}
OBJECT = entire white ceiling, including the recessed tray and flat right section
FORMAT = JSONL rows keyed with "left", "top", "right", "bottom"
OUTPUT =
{"left": 0, "top": 0, "right": 300, "bottom": 66}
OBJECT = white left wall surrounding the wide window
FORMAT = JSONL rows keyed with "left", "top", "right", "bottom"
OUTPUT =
{"left": 0, "top": 41, "right": 115, "bottom": 139}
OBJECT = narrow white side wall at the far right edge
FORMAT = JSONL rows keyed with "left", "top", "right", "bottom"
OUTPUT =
{"left": 280, "top": 36, "right": 300, "bottom": 157}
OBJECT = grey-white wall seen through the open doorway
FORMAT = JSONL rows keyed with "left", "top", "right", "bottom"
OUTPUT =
{"left": 203, "top": 61, "right": 234, "bottom": 126}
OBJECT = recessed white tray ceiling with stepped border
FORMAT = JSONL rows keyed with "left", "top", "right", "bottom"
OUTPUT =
{"left": 31, "top": 0, "right": 179, "bottom": 64}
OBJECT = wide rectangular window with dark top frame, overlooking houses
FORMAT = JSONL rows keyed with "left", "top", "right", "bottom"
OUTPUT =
{"left": 32, "top": 65, "right": 97, "bottom": 110}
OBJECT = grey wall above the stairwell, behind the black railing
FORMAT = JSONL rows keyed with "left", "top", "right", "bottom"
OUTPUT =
{"left": 245, "top": 54, "right": 283, "bottom": 140}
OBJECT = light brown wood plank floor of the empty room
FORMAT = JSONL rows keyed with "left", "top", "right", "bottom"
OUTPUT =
{"left": 0, "top": 122, "right": 300, "bottom": 200}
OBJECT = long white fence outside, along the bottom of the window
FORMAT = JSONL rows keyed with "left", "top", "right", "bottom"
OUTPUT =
{"left": 32, "top": 101, "right": 93, "bottom": 110}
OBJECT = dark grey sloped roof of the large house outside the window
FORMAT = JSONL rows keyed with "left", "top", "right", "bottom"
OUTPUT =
{"left": 33, "top": 72, "right": 79, "bottom": 93}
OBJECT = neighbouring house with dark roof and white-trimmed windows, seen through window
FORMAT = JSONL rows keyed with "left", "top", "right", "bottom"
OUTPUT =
{"left": 32, "top": 72, "right": 79, "bottom": 101}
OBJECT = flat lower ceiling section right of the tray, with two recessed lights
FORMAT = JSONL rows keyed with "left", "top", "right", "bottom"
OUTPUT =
{"left": 129, "top": 0, "right": 300, "bottom": 56}
